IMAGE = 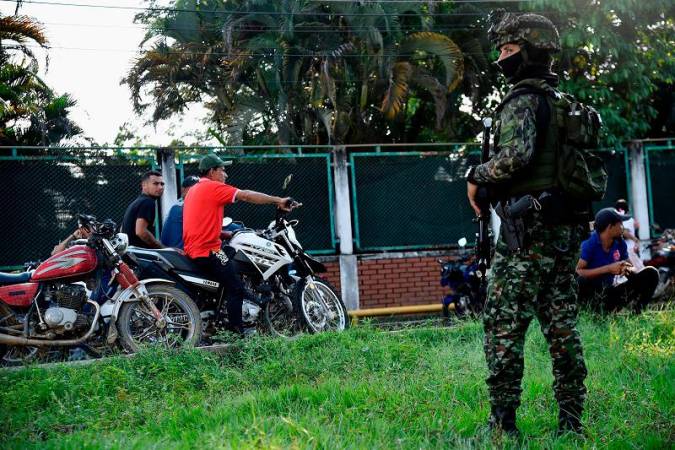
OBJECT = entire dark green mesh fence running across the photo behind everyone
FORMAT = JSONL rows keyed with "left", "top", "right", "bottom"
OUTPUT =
{"left": 0, "top": 142, "right": 675, "bottom": 269}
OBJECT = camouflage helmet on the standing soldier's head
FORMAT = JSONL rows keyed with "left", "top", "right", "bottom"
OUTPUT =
{"left": 488, "top": 9, "right": 560, "bottom": 52}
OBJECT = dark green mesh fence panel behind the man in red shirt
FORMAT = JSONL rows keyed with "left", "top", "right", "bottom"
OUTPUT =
{"left": 181, "top": 152, "right": 336, "bottom": 254}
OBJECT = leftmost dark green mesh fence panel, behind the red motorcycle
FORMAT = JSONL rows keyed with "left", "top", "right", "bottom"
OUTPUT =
{"left": 0, "top": 152, "right": 154, "bottom": 267}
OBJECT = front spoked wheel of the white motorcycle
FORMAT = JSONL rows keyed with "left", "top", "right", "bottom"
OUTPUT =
{"left": 295, "top": 278, "right": 349, "bottom": 333}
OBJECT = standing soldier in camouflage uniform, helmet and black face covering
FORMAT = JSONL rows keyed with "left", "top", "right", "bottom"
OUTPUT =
{"left": 467, "top": 12, "right": 586, "bottom": 435}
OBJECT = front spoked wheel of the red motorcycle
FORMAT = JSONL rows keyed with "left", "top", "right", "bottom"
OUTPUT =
{"left": 117, "top": 284, "right": 202, "bottom": 352}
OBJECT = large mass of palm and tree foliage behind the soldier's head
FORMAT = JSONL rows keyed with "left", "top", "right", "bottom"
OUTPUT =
{"left": 125, "top": 0, "right": 675, "bottom": 145}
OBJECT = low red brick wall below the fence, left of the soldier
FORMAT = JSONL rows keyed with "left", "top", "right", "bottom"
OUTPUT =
{"left": 316, "top": 253, "right": 449, "bottom": 309}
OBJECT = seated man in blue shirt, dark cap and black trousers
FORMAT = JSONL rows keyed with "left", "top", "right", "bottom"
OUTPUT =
{"left": 576, "top": 208, "right": 659, "bottom": 312}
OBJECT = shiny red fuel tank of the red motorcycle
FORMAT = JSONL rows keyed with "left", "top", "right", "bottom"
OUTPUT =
{"left": 31, "top": 245, "right": 96, "bottom": 281}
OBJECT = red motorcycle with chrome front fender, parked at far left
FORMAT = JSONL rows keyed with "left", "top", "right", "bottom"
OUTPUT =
{"left": 0, "top": 215, "right": 202, "bottom": 365}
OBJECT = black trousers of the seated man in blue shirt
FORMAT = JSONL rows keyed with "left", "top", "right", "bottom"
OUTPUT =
{"left": 579, "top": 266, "right": 659, "bottom": 312}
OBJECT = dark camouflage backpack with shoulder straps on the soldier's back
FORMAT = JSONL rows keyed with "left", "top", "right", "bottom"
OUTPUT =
{"left": 501, "top": 84, "right": 608, "bottom": 201}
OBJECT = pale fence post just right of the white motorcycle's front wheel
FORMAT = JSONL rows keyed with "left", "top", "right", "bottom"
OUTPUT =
{"left": 333, "top": 147, "right": 359, "bottom": 310}
